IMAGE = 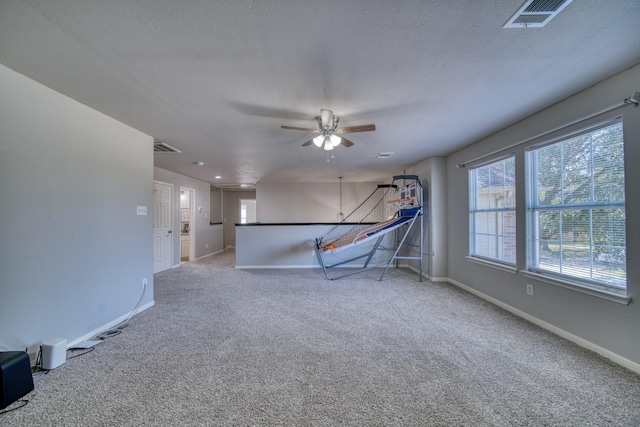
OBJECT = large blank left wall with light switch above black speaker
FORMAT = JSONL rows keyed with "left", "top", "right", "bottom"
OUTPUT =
{"left": 0, "top": 65, "right": 153, "bottom": 350}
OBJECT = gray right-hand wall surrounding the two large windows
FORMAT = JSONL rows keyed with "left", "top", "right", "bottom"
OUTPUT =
{"left": 444, "top": 66, "right": 640, "bottom": 368}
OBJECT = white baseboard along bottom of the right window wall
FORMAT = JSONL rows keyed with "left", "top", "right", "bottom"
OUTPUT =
{"left": 448, "top": 279, "right": 640, "bottom": 374}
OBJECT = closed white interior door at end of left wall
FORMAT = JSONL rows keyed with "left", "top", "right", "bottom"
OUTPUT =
{"left": 153, "top": 181, "right": 173, "bottom": 274}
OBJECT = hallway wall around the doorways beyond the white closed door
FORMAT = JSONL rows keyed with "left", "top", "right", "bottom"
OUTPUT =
{"left": 153, "top": 168, "right": 223, "bottom": 266}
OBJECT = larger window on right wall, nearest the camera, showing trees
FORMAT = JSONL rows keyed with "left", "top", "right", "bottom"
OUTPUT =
{"left": 526, "top": 121, "right": 626, "bottom": 290}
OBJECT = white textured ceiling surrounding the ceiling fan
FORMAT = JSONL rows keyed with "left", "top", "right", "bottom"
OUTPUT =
{"left": 0, "top": 0, "right": 640, "bottom": 184}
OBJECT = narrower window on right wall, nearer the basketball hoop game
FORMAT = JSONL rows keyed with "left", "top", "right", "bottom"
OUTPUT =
{"left": 469, "top": 157, "right": 516, "bottom": 264}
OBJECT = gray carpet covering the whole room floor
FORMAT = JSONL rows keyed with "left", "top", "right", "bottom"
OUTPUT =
{"left": 5, "top": 252, "right": 640, "bottom": 426}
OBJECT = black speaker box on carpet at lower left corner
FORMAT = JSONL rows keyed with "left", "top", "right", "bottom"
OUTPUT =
{"left": 0, "top": 351, "right": 33, "bottom": 409}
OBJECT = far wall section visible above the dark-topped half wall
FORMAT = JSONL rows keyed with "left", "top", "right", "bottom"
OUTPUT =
{"left": 256, "top": 179, "right": 380, "bottom": 223}
